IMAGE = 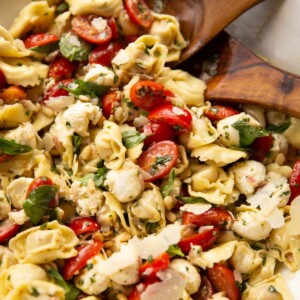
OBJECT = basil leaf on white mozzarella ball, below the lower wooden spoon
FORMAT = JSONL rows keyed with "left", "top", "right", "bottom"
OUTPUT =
{"left": 231, "top": 120, "right": 269, "bottom": 147}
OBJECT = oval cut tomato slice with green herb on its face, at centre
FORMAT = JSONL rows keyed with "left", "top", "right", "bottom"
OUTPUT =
{"left": 137, "top": 141, "right": 178, "bottom": 182}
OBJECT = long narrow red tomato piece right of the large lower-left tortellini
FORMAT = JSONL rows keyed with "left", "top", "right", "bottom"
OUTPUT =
{"left": 63, "top": 240, "right": 103, "bottom": 280}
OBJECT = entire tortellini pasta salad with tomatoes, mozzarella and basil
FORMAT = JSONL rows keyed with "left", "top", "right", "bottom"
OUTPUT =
{"left": 0, "top": 0, "right": 300, "bottom": 300}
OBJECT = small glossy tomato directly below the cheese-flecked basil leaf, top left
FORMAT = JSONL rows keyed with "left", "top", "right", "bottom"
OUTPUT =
{"left": 48, "top": 56, "right": 77, "bottom": 80}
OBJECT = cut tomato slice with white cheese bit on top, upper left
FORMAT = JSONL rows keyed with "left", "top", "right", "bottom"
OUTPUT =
{"left": 72, "top": 15, "right": 112, "bottom": 45}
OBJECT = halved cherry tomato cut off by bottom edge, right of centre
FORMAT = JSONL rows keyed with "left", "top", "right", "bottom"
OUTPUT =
{"left": 207, "top": 264, "right": 239, "bottom": 300}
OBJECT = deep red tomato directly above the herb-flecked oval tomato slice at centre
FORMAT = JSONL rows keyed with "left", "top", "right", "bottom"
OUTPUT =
{"left": 143, "top": 121, "right": 175, "bottom": 147}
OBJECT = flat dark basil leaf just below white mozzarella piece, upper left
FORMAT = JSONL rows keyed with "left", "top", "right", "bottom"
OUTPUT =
{"left": 63, "top": 79, "right": 110, "bottom": 98}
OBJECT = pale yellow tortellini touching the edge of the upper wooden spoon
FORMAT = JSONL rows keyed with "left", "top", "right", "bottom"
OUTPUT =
{"left": 149, "top": 13, "right": 187, "bottom": 62}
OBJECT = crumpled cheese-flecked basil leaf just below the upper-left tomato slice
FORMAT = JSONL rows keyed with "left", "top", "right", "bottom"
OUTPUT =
{"left": 59, "top": 32, "right": 92, "bottom": 61}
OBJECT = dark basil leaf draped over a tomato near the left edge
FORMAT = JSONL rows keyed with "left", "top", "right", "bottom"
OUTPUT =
{"left": 23, "top": 185, "right": 58, "bottom": 225}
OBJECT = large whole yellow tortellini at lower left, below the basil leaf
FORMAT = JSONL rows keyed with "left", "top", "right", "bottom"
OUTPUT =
{"left": 9, "top": 221, "right": 78, "bottom": 264}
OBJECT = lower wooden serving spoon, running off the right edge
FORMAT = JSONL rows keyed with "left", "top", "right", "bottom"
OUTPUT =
{"left": 206, "top": 35, "right": 300, "bottom": 117}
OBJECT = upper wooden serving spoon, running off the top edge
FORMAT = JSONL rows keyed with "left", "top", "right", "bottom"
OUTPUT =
{"left": 147, "top": 0, "right": 263, "bottom": 66}
